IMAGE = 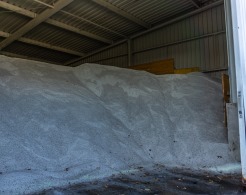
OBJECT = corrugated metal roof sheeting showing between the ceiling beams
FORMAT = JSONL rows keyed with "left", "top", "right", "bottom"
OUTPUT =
{"left": 0, "top": 0, "right": 221, "bottom": 63}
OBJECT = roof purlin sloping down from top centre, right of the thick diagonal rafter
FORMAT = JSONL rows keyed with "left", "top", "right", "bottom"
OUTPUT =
{"left": 92, "top": 0, "right": 151, "bottom": 29}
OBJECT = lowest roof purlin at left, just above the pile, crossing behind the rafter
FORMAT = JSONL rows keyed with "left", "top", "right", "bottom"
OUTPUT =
{"left": 0, "top": 31, "right": 85, "bottom": 57}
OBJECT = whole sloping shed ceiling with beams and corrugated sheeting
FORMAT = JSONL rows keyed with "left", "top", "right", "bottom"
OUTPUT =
{"left": 0, "top": 0, "right": 221, "bottom": 65}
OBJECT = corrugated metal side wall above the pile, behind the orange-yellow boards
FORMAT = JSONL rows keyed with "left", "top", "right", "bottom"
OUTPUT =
{"left": 77, "top": 5, "right": 227, "bottom": 75}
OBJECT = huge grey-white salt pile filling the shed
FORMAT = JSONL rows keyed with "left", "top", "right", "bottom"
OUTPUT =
{"left": 0, "top": 56, "right": 233, "bottom": 194}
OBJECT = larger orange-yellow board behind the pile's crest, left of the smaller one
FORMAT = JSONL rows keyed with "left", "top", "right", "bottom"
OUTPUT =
{"left": 128, "top": 59, "right": 174, "bottom": 75}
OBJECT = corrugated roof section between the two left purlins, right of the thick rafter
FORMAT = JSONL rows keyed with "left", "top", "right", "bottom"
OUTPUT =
{"left": 24, "top": 24, "right": 106, "bottom": 53}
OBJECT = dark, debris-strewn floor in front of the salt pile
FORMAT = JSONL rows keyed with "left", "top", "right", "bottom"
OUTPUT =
{"left": 38, "top": 166, "right": 246, "bottom": 195}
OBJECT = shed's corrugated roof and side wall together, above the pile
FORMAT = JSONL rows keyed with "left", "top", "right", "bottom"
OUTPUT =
{"left": 0, "top": 0, "right": 227, "bottom": 76}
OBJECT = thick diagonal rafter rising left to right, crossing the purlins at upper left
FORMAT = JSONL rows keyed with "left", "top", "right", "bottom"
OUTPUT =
{"left": 0, "top": 0, "right": 73, "bottom": 50}
